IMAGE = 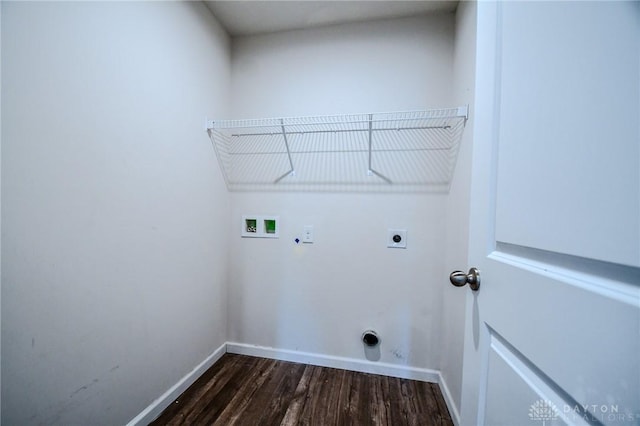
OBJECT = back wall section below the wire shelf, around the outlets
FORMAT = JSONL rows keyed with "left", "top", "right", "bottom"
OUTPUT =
{"left": 228, "top": 193, "right": 444, "bottom": 368}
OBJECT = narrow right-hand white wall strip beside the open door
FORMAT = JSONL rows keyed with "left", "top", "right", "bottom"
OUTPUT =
{"left": 440, "top": 2, "right": 476, "bottom": 416}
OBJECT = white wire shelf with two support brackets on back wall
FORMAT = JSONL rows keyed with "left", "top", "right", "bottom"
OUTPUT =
{"left": 207, "top": 106, "right": 468, "bottom": 191}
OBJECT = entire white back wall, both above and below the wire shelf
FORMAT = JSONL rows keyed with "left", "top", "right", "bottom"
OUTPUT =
{"left": 228, "top": 14, "right": 454, "bottom": 369}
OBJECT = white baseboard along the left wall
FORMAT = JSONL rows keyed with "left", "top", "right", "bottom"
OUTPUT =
{"left": 127, "top": 343, "right": 227, "bottom": 426}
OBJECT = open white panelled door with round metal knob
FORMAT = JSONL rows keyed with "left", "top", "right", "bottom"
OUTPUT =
{"left": 461, "top": 2, "right": 640, "bottom": 426}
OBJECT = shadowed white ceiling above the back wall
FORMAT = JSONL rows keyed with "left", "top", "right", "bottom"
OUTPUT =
{"left": 204, "top": 0, "right": 458, "bottom": 36}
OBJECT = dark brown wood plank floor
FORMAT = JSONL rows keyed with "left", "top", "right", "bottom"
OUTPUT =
{"left": 151, "top": 354, "right": 453, "bottom": 426}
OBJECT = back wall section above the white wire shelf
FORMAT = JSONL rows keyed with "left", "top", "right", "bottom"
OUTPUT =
{"left": 231, "top": 14, "right": 454, "bottom": 118}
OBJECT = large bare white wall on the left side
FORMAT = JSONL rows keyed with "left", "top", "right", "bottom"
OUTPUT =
{"left": 2, "top": 2, "right": 230, "bottom": 425}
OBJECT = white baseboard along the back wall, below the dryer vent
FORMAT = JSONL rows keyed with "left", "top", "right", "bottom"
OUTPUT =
{"left": 227, "top": 342, "right": 440, "bottom": 383}
